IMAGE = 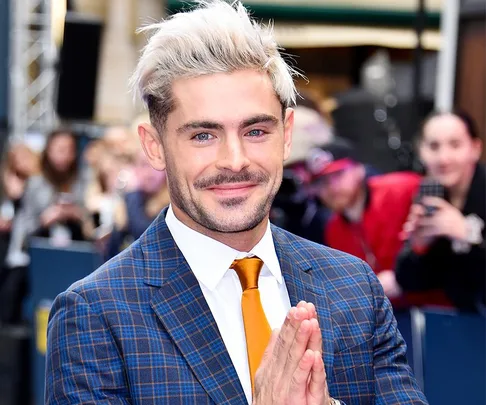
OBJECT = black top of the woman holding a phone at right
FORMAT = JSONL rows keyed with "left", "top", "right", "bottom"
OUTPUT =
{"left": 395, "top": 164, "right": 486, "bottom": 312}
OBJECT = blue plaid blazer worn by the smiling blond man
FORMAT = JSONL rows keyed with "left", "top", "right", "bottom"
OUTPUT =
{"left": 45, "top": 212, "right": 427, "bottom": 405}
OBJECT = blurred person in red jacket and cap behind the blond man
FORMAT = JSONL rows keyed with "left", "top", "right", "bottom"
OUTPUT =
{"left": 307, "top": 142, "right": 421, "bottom": 308}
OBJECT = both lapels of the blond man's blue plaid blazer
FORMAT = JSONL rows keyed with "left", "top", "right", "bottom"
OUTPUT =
{"left": 140, "top": 209, "right": 334, "bottom": 404}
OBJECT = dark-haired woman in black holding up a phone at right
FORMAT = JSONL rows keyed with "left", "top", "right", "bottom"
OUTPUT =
{"left": 396, "top": 112, "right": 486, "bottom": 311}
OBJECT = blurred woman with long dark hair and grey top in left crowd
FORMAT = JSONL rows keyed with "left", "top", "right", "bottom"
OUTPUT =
{"left": 0, "top": 129, "right": 92, "bottom": 323}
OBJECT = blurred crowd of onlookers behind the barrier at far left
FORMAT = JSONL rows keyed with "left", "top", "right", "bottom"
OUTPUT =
{"left": 0, "top": 113, "right": 169, "bottom": 324}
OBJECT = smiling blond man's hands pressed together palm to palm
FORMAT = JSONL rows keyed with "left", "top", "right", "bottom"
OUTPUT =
{"left": 253, "top": 302, "right": 330, "bottom": 405}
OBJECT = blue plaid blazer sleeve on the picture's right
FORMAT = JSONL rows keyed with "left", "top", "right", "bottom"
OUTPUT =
{"left": 365, "top": 265, "right": 428, "bottom": 405}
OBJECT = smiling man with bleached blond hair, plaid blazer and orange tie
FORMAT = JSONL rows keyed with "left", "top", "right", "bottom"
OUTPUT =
{"left": 46, "top": 1, "right": 426, "bottom": 405}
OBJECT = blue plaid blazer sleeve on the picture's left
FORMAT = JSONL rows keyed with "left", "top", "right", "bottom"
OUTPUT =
{"left": 45, "top": 291, "right": 130, "bottom": 405}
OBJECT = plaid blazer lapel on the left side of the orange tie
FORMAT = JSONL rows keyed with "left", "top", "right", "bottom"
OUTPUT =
{"left": 142, "top": 211, "right": 247, "bottom": 404}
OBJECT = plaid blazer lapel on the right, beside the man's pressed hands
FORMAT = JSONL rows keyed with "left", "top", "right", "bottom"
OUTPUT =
{"left": 272, "top": 227, "right": 334, "bottom": 376}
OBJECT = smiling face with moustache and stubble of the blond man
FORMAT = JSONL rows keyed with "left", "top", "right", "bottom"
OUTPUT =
{"left": 140, "top": 70, "right": 293, "bottom": 233}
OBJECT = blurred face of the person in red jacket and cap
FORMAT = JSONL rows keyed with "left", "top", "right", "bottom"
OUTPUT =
{"left": 316, "top": 164, "right": 364, "bottom": 213}
